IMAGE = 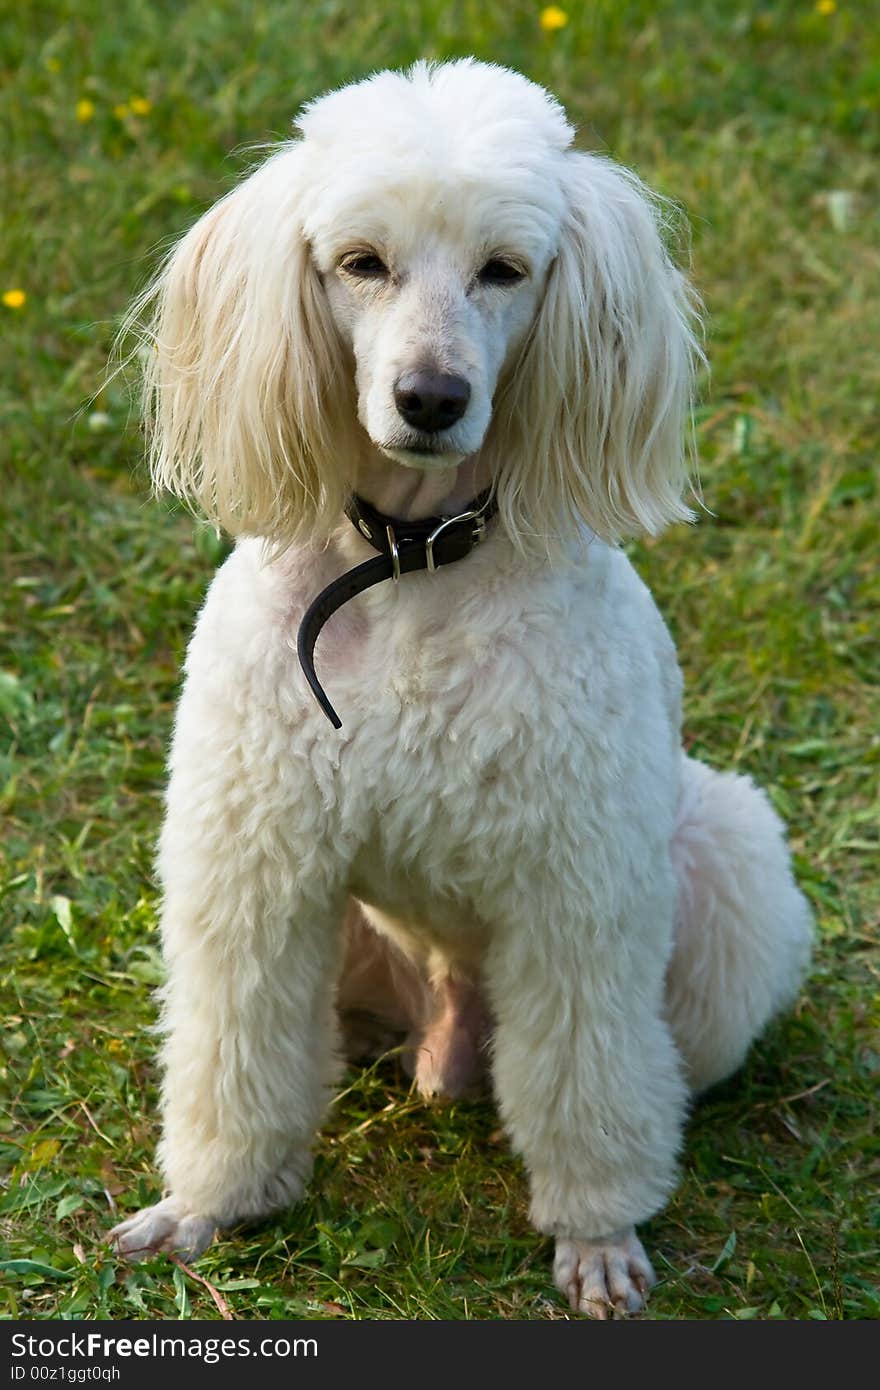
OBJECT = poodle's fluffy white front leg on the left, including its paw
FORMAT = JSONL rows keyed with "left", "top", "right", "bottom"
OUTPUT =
{"left": 113, "top": 706, "right": 345, "bottom": 1258}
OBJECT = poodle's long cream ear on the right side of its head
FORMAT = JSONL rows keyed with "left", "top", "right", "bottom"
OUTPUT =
{"left": 499, "top": 153, "right": 702, "bottom": 543}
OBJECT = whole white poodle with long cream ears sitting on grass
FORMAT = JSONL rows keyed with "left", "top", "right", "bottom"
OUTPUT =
{"left": 113, "top": 60, "right": 812, "bottom": 1318}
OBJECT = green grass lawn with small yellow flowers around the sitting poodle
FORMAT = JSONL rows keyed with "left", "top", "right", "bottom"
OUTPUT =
{"left": 0, "top": 0, "right": 880, "bottom": 1319}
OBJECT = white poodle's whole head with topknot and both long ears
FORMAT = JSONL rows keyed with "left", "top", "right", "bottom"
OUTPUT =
{"left": 139, "top": 60, "right": 698, "bottom": 545}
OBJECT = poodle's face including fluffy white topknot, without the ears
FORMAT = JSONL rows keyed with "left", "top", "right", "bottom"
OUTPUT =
{"left": 293, "top": 64, "right": 570, "bottom": 470}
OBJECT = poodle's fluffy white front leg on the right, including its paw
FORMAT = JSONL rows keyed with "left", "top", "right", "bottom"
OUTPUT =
{"left": 487, "top": 883, "right": 685, "bottom": 1318}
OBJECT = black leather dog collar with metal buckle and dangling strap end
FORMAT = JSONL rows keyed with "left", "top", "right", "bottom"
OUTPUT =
{"left": 296, "top": 488, "right": 498, "bottom": 728}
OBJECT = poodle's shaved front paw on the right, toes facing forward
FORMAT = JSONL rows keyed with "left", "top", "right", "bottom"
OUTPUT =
{"left": 553, "top": 1229, "right": 655, "bottom": 1319}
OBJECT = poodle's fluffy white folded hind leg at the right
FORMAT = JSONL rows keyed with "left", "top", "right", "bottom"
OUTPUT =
{"left": 667, "top": 758, "right": 812, "bottom": 1091}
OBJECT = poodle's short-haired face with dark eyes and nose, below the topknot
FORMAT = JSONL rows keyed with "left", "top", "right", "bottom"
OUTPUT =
{"left": 314, "top": 190, "right": 556, "bottom": 470}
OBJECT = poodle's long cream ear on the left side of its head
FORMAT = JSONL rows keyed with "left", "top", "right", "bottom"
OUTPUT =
{"left": 132, "top": 146, "right": 355, "bottom": 543}
